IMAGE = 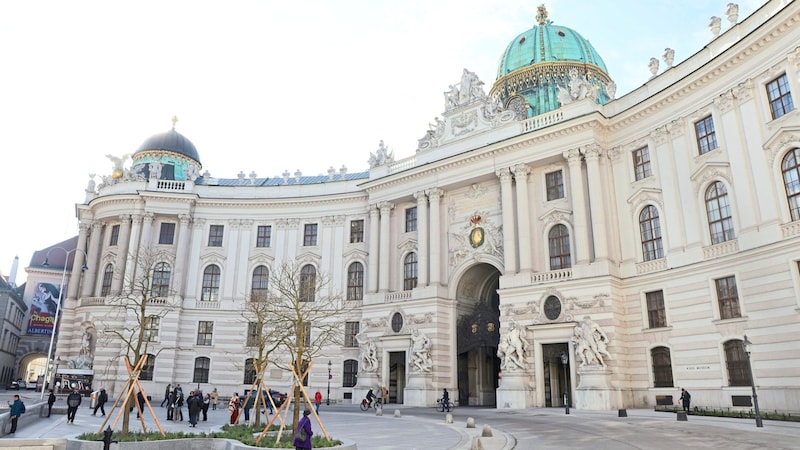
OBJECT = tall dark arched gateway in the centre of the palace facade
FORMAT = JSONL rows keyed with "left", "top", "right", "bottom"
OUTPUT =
{"left": 456, "top": 264, "right": 500, "bottom": 406}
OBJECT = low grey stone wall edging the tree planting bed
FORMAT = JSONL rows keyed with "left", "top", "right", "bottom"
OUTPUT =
{"left": 64, "top": 438, "right": 358, "bottom": 450}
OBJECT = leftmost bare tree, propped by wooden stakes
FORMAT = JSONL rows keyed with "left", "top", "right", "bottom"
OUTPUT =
{"left": 102, "top": 249, "right": 175, "bottom": 434}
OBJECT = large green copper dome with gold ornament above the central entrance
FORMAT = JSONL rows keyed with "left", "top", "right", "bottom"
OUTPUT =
{"left": 491, "top": 6, "right": 613, "bottom": 117}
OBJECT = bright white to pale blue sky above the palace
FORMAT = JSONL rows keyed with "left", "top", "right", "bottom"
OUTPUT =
{"left": 0, "top": 0, "right": 765, "bottom": 284}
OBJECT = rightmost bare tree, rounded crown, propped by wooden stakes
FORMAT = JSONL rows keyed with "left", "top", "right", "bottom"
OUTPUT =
{"left": 266, "top": 263, "right": 349, "bottom": 429}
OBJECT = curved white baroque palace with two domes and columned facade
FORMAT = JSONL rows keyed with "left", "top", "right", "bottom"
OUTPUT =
{"left": 23, "top": 1, "right": 800, "bottom": 411}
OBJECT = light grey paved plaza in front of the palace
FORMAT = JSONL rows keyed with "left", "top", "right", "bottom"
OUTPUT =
{"left": 0, "top": 393, "right": 800, "bottom": 450}
